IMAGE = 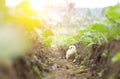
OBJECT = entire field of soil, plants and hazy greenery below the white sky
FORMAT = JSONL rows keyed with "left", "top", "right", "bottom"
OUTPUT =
{"left": 0, "top": 0, "right": 120, "bottom": 79}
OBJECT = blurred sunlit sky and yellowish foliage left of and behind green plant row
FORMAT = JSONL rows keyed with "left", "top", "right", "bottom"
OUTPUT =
{"left": 0, "top": 0, "right": 120, "bottom": 61}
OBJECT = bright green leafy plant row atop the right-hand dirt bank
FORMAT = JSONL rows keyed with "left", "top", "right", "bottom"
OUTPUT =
{"left": 65, "top": 4, "right": 120, "bottom": 46}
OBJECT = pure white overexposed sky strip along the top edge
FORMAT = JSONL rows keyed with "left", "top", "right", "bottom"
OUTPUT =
{"left": 6, "top": 0, "right": 120, "bottom": 10}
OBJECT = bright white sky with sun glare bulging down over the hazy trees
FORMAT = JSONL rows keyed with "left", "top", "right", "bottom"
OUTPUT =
{"left": 6, "top": 0, "right": 120, "bottom": 24}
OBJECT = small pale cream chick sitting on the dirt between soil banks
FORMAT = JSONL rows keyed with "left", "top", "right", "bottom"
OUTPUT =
{"left": 66, "top": 45, "right": 77, "bottom": 59}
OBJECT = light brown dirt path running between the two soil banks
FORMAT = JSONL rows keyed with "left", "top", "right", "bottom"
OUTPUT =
{"left": 46, "top": 49, "right": 91, "bottom": 79}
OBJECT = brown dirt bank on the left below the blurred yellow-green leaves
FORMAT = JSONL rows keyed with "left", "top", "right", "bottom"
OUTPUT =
{"left": 0, "top": 40, "right": 50, "bottom": 79}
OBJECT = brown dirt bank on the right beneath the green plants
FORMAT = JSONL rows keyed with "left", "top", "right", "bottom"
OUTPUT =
{"left": 75, "top": 40, "right": 120, "bottom": 79}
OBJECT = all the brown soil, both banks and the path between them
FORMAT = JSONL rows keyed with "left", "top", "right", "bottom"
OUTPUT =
{"left": 0, "top": 40, "right": 120, "bottom": 79}
